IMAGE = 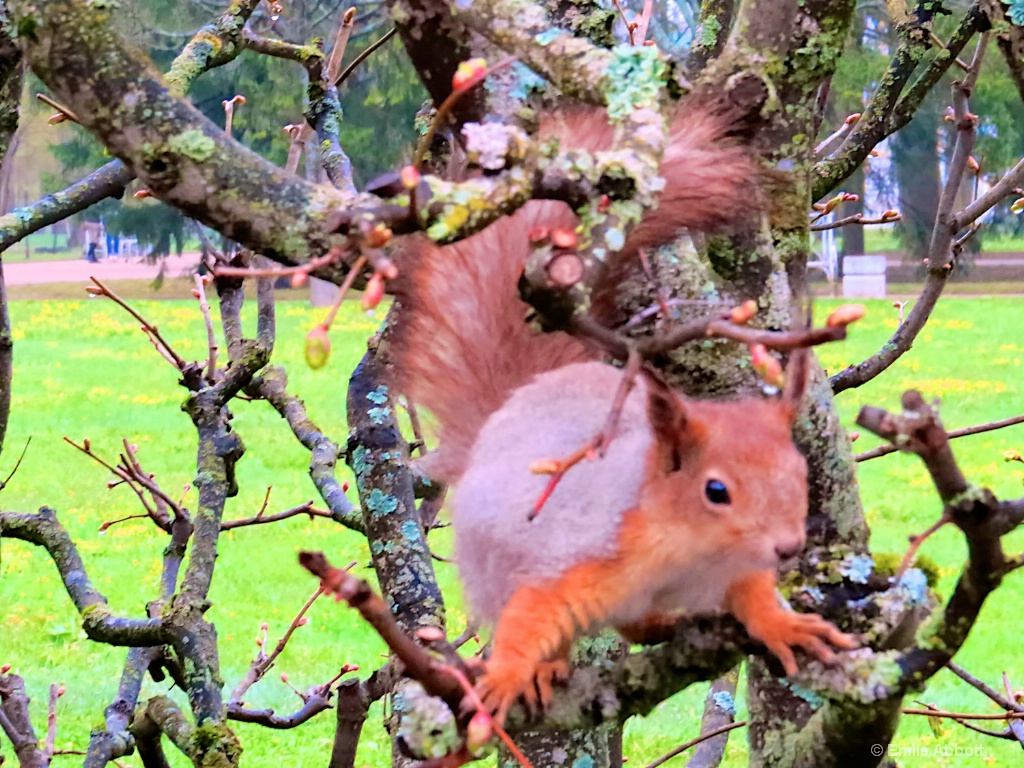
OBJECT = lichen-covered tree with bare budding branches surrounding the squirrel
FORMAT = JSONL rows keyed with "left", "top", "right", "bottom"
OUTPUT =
{"left": 0, "top": 0, "right": 1024, "bottom": 767}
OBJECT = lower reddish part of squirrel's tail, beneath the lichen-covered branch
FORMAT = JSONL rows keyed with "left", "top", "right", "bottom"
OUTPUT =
{"left": 392, "top": 201, "right": 593, "bottom": 482}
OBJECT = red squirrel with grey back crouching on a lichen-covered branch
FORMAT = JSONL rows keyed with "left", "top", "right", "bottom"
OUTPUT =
{"left": 392, "top": 97, "right": 856, "bottom": 721}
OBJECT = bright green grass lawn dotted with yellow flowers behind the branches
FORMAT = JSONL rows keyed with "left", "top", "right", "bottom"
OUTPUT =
{"left": 0, "top": 298, "right": 1024, "bottom": 768}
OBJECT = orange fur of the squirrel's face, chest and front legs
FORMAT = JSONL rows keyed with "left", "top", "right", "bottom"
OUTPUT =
{"left": 471, "top": 388, "right": 856, "bottom": 729}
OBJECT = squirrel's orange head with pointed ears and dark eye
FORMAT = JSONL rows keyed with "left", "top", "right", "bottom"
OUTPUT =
{"left": 644, "top": 350, "right": 808, "bottom": 569}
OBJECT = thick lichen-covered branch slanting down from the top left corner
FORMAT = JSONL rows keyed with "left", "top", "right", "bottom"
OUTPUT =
{"left": 10, "top": 0, "right": 346, "bottom": 276}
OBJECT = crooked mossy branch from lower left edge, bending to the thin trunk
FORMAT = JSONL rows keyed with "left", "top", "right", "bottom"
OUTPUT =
{"left": 0, "top": 507, "right": 168, "bottom": 646}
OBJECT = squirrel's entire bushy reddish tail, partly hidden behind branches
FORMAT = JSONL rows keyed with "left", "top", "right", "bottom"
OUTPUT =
{"left": 393, "top": 96, "right": 759, "bottom": 482}
